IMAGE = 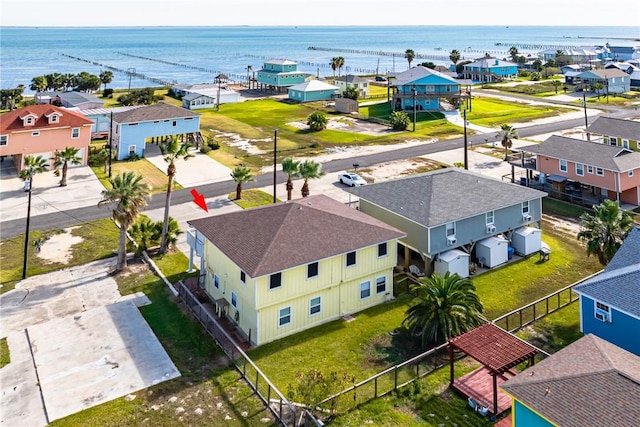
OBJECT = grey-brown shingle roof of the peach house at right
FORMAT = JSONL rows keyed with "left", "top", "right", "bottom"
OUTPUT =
{"left": 519, "top": 135, "right": 640, "bottom": 172}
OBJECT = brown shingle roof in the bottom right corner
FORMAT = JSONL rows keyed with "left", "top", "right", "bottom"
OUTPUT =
{"left": 502, "top": 334, "right": 640, "bottom": 427}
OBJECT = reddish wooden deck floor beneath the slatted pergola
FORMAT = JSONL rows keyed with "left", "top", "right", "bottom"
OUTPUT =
{"left": 451, "top": 367, "right": 511, "bottom": 416}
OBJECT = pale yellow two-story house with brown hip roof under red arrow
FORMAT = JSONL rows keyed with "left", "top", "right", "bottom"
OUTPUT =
{"left": 188, "top": 195, "right": 405, "bottom": 346}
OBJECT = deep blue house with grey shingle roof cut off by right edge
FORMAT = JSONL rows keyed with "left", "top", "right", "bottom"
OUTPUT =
{"left": 573, "top": 227, "right": 640, "bottom": 356}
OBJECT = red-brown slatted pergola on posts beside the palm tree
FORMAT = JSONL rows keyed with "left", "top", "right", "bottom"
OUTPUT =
{"left": 449, "top": 323, "right": 538, "bottom": 415}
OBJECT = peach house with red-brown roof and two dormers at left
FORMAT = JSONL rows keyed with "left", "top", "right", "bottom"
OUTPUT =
{"left": 0, "top": 105, "right": 93, "bottom": 170}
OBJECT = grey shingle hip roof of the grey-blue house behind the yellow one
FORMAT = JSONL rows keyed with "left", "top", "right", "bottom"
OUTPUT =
{"left": 347, "top": 168, "right": 546, "bottom": 227}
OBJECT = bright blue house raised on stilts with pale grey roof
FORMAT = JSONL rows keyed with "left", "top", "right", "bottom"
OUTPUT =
{"left": 391, "top": 65, "right": 466, "bottom": 111}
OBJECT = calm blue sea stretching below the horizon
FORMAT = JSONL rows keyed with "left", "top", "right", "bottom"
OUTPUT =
{"left": 0, "top": 26, "right": 640, "bottom": 93}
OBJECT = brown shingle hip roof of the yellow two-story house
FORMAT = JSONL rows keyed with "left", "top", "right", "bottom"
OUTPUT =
{"left": 188, "top": 194, "right": 406, "bottom": 277}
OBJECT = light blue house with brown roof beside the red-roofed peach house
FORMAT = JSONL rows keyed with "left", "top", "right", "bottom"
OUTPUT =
{"left": 112, "top": 102, "right": 200, "bottom": 160}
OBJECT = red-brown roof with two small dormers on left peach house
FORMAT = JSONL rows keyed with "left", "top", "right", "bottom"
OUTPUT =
{"left": 0, "top": 104, "right": 93, "bottom": 134}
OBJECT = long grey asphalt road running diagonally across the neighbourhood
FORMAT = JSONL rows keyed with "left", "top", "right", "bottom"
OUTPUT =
{"left": 0, "top": 102, "right": 638, "bottom": 239}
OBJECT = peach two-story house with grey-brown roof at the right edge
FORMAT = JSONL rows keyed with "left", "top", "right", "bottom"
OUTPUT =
{"left": 520, "top": 135, "right": 640, "bottom": 206}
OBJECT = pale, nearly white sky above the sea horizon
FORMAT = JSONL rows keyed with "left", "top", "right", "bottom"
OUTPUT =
{"left": 0, "top": 0, "right": 640, "bottom": 27}
